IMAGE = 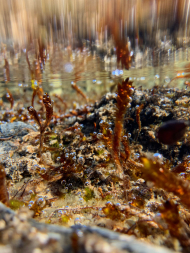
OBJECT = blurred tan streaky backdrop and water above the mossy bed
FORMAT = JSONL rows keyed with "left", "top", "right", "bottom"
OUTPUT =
{"left": 0, "top": 0, "right": 190, "bottom": 102}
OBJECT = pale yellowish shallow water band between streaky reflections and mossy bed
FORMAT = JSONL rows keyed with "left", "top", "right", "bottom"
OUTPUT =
{"left": 0, "top": 45, "right": 190, "bottom": 103}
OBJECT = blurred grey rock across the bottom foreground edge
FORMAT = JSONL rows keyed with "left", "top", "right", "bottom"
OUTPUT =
{"left": 0, "top": 203, "right": 176, "bottom": 253}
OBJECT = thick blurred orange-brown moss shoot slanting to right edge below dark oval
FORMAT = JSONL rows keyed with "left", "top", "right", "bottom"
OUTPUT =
{"left": 141, "top": 157, "right": 190, "bottom": 209}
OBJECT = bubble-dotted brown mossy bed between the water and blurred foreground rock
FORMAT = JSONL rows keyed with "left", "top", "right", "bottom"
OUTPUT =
{"left": 0, "top": 66, "right": 190, "bottom": 252}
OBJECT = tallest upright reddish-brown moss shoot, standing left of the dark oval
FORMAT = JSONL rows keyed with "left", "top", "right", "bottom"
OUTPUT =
{"left": 112, "top": 78, "right": 133, "bottom": 173}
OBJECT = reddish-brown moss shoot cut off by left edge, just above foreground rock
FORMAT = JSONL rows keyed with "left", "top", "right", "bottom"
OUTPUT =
{"left": 0, "top": 164, "right": 9, "bottom": 206}
